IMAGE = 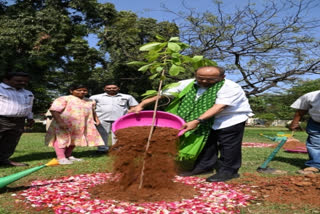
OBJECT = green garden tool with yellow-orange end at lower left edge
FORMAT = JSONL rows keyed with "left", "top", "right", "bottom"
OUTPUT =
{"left": 0, "top": 158, "right": 59, "bottom": 189}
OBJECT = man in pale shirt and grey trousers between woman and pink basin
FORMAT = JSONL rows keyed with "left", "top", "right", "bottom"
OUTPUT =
{"left": 90, "top": 83, "right": 138, "bottom": 154}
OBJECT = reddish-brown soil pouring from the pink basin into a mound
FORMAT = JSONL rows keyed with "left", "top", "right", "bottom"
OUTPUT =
{"left": 91, "top": 127, "right": 197, "bottom": 203}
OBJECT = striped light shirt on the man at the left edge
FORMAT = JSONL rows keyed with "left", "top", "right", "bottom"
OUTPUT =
{"left": 0, "top": 83, "right": 34, "bottom": 119}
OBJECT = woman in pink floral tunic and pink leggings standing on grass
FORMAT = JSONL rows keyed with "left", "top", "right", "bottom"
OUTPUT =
{"left": 45, "top": 84, "right": 104, "bottom": 164}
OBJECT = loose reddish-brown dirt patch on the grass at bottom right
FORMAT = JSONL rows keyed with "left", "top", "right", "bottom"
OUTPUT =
{"left": 230, "top": 173, "right": 320, "bottom": 208}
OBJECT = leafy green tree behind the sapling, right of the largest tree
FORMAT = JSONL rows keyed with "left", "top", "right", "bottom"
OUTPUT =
{"left": 98, "top": 11, "right": 179, "bottom": 98}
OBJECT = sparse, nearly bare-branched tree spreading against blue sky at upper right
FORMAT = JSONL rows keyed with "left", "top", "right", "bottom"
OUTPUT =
{"left": 165, "top": 0, "right": 320, "bottom": 96}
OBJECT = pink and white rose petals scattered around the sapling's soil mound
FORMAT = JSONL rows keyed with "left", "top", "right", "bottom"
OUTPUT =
{"left": 12, "top": 173, "right": 253, "bottom": 214}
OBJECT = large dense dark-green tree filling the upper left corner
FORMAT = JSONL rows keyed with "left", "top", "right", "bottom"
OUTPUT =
{"left": 0, "top": 0, "right": 116, "bottom": 112}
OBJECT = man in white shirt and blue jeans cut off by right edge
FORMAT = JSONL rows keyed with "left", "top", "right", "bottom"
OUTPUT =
{"left": 289, "top": 90, "right": 320, "bottom": 174}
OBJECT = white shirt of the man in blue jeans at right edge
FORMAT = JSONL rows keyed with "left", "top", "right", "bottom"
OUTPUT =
{"left": 290, "top": 90, "right": 320, "bottom": 123}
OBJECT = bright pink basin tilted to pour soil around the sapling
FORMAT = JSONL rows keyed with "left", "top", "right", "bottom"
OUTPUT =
{"left": 112, "top": 111, "right": 185, "bottom": 136}
